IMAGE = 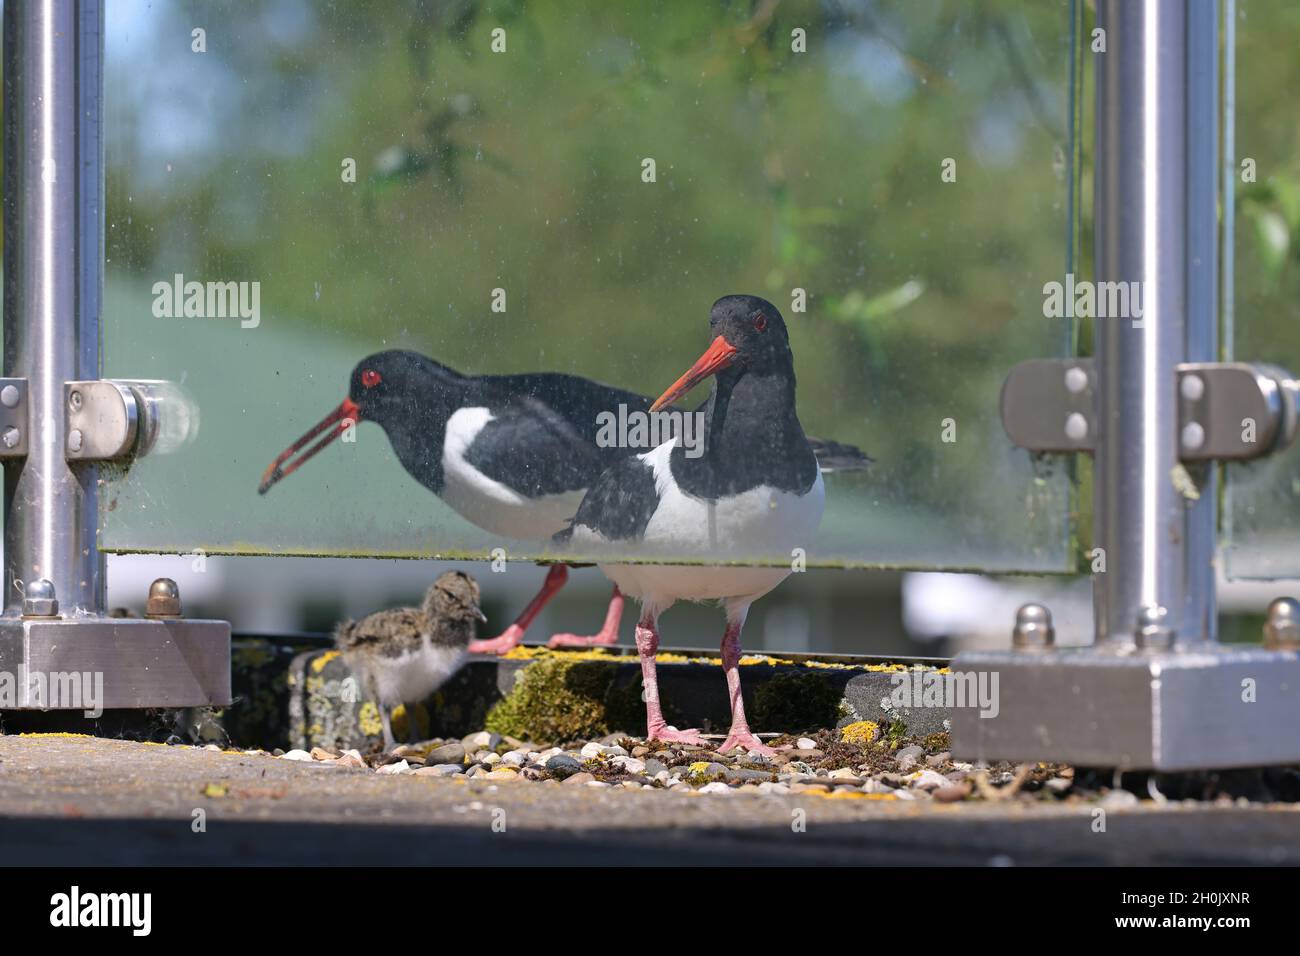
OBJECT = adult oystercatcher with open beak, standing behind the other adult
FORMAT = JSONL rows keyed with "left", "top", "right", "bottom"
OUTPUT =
{"left": 257, "top": 350, "right": 871, "bottom": 653}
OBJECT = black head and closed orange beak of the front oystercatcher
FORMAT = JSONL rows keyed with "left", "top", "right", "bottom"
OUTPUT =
{"left": 651, "top": 295, "right": 794, "bottom": 411}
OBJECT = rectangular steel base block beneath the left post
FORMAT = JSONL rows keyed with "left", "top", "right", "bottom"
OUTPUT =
{"left": 0, "top": 618, "right": 230, "bottom": 711}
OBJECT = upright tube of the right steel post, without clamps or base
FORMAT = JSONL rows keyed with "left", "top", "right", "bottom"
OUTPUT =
{"left": 1093, "top": 0, "right": 1218, "bottom": 646}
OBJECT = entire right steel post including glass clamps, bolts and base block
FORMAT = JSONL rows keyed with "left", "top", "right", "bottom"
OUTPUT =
{"left": 953, "top": 0, "right": 1300, "bottom": 770}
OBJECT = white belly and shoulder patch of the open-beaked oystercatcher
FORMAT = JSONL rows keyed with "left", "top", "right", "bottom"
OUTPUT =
{"left": 439, "top": 408, "right": 585, "bottom": 541}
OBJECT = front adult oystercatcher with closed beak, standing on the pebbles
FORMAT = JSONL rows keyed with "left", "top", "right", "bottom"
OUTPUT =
{"left": 559, "top": 295, "right": 826, "bottom": 754}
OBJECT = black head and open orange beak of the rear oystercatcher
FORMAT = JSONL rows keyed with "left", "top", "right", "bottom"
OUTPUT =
{"left": 257, "top": 349, "right": 459, "bottom": 494}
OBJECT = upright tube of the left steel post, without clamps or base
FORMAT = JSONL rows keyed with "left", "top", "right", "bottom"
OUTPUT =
{"left": 4, "top": 0, "right": 104, "bottom": 617}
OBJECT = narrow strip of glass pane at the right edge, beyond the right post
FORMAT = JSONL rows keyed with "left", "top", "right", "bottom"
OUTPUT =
{"left": 1223, "top": 0, "right": 1300, "bottom": 578}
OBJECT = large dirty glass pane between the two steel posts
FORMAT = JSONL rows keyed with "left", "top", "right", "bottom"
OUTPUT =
{"left": 100, "top": 0, "right": 1073, "bottom": 571}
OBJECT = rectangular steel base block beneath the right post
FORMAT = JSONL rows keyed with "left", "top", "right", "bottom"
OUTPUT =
{"left": 953, "top": 646, "right": 1300, "bottom": 771}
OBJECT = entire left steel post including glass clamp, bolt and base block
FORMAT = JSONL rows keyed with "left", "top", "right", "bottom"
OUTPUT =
{"left": 0, "top": 0, "right": 230, "bottom": 714}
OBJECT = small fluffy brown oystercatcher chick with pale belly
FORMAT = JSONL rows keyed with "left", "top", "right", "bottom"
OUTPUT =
{"left": 334, "top": 571, "right": 488, "bottom": 750}
